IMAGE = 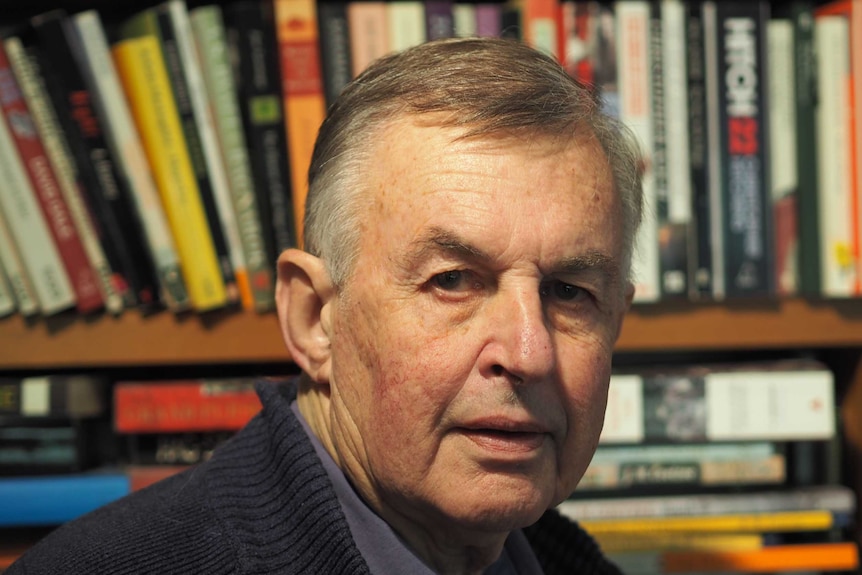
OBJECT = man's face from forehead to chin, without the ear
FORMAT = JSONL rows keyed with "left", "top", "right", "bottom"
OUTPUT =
{"left": 330, "top": 119, "right": 626, "bottom": 544}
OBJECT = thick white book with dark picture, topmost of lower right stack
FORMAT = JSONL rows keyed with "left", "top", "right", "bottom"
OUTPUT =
{"left": 600, "top": 360, "right": 835, "bottom": 443}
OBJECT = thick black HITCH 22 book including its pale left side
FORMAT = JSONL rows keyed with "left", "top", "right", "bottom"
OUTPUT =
{"left": 702, "top": 2, "right": 775, "bottom": 299}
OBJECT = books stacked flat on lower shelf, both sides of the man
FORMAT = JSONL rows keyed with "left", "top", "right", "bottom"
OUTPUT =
{"left": 0, "top": 360, "right": 858, "bottom": 573}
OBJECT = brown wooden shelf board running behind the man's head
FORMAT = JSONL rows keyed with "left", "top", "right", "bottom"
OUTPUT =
{"left": 5, "top": 299, "right": 862, "bottom": 370}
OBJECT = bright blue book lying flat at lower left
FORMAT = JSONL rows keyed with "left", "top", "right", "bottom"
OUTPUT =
{"left": 0, "top": 470, "right": 130, "bottom": 527}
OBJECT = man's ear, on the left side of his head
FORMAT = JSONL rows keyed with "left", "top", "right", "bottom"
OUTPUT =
{"left": 275, "top": 249, "right": 335, "bottom": 384}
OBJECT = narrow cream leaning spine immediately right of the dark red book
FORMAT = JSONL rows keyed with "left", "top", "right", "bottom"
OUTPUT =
{"left": 4, "top": 36, "right": 125, "bottom": 314}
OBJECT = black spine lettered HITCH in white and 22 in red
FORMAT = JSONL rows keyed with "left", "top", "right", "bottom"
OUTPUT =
{"left": 716, "top": 2, "right": 775, "bottom": 297}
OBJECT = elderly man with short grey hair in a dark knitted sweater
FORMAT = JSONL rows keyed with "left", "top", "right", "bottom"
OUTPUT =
{"left": 8, "top": 39, "right": 641, "bottom": 575}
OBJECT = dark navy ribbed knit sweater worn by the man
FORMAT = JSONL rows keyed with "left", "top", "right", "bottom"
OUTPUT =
{"left": 10, "top": 383, "right": 619, "bottom": 575}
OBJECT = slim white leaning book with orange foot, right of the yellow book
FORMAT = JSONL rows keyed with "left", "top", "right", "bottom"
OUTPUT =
{"left": 166, "top": 0, "right": 250, "bottom": 303}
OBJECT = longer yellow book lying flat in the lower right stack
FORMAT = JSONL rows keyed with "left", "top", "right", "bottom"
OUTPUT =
{"left": 580, "top": 510, "right": 833, "bottom": 536}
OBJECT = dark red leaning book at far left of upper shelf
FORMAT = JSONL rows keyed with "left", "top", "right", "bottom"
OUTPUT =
{"left": 0, "top": 43, "right": 104, "bottom": 313}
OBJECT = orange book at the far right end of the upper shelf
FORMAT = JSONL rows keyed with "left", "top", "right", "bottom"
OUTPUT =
{"left": 814, "top": 0, "right": 862, "bottom": 296}
